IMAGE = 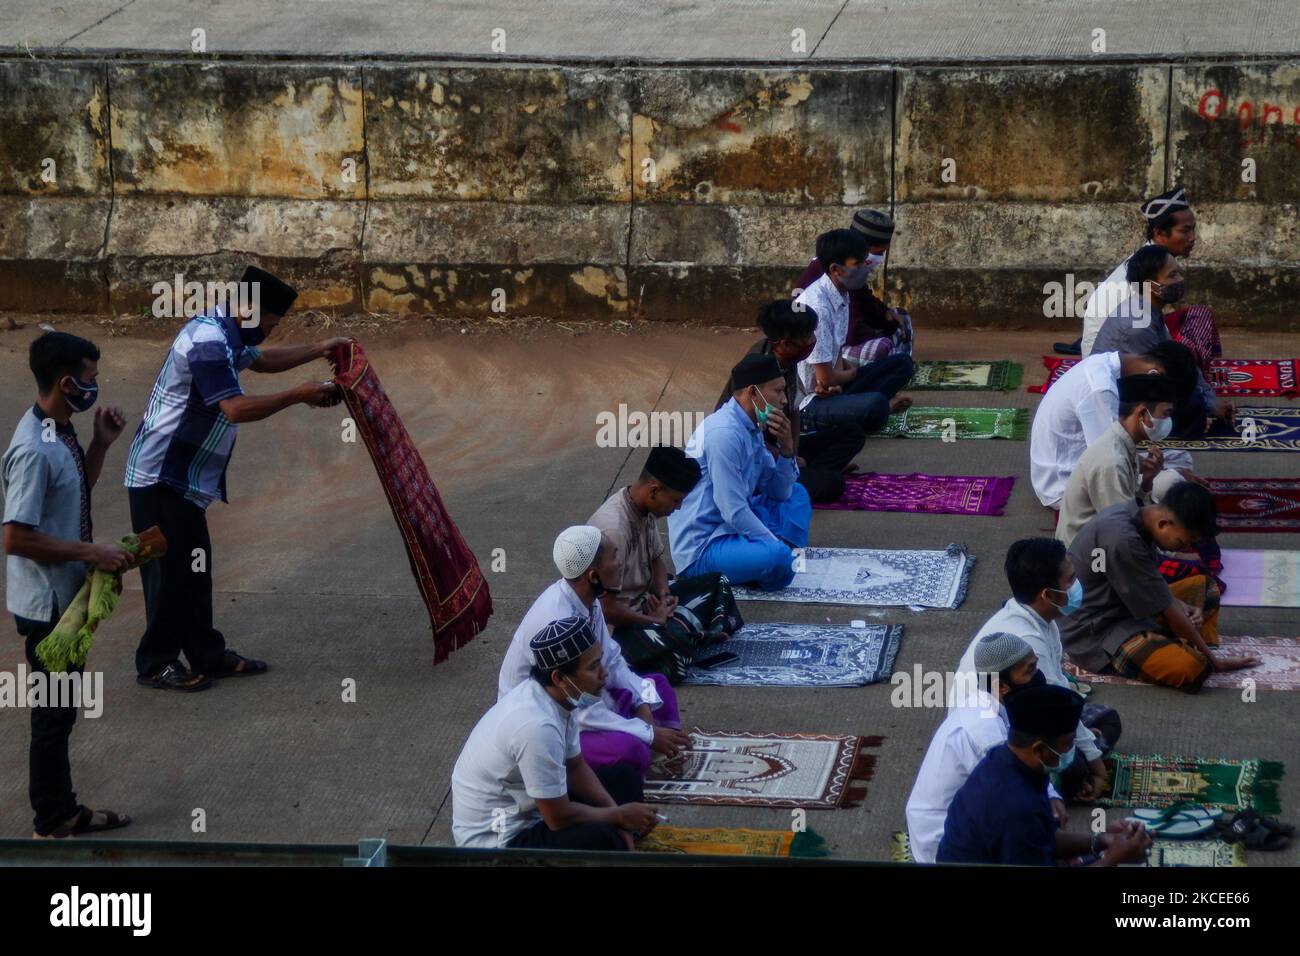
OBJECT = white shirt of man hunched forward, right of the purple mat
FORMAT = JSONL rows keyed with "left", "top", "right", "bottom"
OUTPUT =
{"left": 1030, "top": 352, "right": 1119, "bottom": 507}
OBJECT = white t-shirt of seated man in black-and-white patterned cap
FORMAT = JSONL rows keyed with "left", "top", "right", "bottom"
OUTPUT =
{"left": 451, "top": 680, "right": 582, "bottom": 848}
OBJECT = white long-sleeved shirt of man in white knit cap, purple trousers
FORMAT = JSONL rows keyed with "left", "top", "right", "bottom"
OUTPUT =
{"left": 497, "top": 578, "right": 663, "bottom": 744}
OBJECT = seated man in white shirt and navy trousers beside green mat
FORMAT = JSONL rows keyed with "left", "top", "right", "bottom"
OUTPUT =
{"left": 794, "top": 229, "right": 915, "bottom": 432}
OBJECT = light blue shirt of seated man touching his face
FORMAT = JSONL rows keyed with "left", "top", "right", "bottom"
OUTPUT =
{"left": 668, "top": 398, "right": 798, "bottom": 572}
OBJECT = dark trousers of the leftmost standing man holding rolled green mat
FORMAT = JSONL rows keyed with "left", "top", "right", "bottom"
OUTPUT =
{"left": 14, "top": 609, "right": 82, "bottom": 836}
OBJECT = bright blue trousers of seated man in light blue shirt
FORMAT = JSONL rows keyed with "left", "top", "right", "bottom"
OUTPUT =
{"left": 679, "top": 484, "right": 813, "bottom": 591}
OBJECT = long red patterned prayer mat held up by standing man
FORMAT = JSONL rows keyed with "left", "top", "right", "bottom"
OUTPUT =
{"left": 332, "top": 342, "right": 491, "bottom": 663}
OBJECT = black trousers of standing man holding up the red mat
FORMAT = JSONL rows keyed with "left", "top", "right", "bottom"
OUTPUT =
{"left": 127, "top": 485, "right": 226, "bottom": 678}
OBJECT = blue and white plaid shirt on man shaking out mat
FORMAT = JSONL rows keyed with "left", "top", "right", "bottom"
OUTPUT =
{"left": 126, "top": 308, "right": 261, "bottom": 509}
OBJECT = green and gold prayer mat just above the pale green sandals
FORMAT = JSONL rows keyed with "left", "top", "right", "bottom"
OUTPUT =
{"left": 1097, "top": 753, "right": 1283, "bottom": 813}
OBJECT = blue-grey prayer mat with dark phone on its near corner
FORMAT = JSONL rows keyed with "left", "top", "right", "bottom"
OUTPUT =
{"left": 681, "top": 624, "right": 902, "bottom": 687}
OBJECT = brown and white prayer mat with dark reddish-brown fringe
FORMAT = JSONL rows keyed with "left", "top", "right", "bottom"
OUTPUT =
{"left": 645, "top": 727, "right": 884, "bottom": 810}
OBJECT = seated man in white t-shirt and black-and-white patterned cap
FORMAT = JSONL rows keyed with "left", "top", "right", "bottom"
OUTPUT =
{"left": 451, "top": 617, "right": 658, "bottom": 851}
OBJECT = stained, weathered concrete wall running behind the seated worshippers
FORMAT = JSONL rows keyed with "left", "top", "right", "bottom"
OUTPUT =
{"left": 0, "top": 59, "right": 1300, "bottom": 326}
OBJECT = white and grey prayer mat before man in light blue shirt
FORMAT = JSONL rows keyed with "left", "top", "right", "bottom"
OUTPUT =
{"left": 735, "top": 545, "right": 975, "bottom": 609}
